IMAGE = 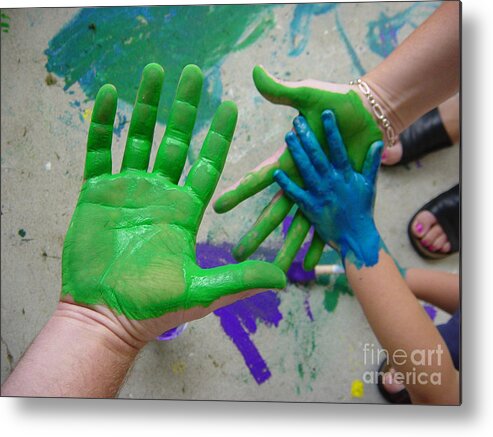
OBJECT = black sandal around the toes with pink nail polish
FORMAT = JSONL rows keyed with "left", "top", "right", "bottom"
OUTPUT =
{"left": 407, "top": 184, "right": 460, "bottom": 259}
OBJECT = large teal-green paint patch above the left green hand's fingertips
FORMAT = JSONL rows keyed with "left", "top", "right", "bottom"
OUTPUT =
{"left": 45, "top": 5, "right": 274, "bottom": 138}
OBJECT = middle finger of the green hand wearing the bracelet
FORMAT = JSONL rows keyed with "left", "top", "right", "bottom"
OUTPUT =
{"left": 232, "top": 191, "right": 293, "bottom": 261}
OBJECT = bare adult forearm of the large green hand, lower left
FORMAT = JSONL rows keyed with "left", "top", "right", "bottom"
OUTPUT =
{"left": 2, "top": 303, "right": 142, "bottom": 398}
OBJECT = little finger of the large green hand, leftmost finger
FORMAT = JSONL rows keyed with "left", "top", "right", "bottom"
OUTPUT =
{"left": 84, "top": 84, "right": 118, "bottom": 179}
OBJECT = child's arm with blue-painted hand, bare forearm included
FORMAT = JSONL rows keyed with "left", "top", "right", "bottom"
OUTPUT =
{"left": 274, "top": 111, "right": 459, "bottom": 404}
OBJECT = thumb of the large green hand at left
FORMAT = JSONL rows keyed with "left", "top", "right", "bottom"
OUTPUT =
{"left": 189, "top": 261, "right": 286, "bottom": 307}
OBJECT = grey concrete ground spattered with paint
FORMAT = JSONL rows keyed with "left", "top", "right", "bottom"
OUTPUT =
{"left": 1, "top": 2, "right": 459, "bottom": 403}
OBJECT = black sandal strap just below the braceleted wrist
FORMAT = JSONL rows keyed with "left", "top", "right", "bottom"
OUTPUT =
{"left": 398, "top": 108, "right": 453, "bottom": 164}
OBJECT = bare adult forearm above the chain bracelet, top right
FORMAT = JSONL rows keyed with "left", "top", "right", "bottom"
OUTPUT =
{"left": 363, "top": 1, "right": 461, "bottom": 132}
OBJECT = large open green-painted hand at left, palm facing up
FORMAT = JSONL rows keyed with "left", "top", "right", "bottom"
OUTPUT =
{"left": 62, "top": 64, "right": 285, "bottom": 332}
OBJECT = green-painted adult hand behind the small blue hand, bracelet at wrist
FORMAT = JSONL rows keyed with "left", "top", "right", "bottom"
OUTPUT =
{"left": 214, "top": 66, "right": 382, "bottom": 271}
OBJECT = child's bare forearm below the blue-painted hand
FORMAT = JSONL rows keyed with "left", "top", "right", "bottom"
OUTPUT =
{"left": 346, "top": 250, "right": 459, "bottom": 404}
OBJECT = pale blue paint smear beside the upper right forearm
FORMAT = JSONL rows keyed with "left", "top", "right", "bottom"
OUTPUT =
{"left": 366, "top": 2, "right": 441, "bottom": 58}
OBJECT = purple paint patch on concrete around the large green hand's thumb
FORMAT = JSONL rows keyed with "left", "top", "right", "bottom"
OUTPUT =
{"left": 196, "top": 243, "right": 282, "bottom": 384}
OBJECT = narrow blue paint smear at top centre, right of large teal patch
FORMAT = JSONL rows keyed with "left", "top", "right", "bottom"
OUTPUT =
{"left": 288, "top": 3, "right": 337, "bottom": 57}
